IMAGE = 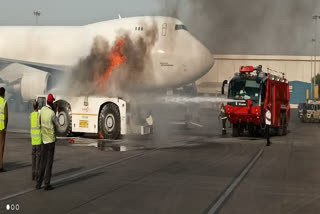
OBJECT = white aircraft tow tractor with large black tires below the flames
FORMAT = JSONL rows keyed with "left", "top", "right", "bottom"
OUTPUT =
{"left": 37, "top": 96, "right": 153, "bottom": 140}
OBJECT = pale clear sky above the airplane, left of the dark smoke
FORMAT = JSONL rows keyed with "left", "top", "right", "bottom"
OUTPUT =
{"left": 0, "top": 0, "right": 161, "bottom": 25}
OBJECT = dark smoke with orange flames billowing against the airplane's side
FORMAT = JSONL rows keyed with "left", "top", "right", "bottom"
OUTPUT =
{"left": 67, "top": 20, "right": 158, "bottom": 96}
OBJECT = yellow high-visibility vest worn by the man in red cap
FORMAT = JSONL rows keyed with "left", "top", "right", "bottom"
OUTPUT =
{"left": 40, "top": 106, "right": 56, "bottom": 142}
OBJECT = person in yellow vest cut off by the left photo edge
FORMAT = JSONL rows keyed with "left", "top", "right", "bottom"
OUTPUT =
{"left": 0, "top": 87, "right": 8, "bottom": 173}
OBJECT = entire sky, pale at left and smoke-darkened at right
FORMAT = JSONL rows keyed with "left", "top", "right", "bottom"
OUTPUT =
{"left": 0, "top": 0, "right": 320, "bottom": 55}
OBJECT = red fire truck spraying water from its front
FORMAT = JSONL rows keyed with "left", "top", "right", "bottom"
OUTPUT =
{"left": 222, "top": 65, "right": 290, "bottom": 137}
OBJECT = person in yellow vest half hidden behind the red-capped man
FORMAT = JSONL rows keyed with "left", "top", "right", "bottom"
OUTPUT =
{"left": 30, "top": 100, "right": 42, "bottom": 181}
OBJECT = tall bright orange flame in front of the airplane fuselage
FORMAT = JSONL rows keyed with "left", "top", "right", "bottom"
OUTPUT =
{"left": 97, "top": 38, "right": 127, "bottom": 91}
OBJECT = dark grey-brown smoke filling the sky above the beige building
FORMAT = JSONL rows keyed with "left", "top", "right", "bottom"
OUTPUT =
{"left": 159, "top": 0, "right": 320, "bottom": 55}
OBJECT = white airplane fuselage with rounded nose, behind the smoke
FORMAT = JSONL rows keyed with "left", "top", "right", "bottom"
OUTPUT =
{"left": 0, "top": 17, "right": 214, "bottom": 88}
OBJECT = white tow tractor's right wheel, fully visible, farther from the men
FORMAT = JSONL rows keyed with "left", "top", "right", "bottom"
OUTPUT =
{"left": 99, "top": 103, "right": 120, "bottom": 140}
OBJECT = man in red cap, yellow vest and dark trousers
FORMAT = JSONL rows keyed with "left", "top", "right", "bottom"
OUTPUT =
{"left": 36, "top": 94, "right": 58, "bottom": 191}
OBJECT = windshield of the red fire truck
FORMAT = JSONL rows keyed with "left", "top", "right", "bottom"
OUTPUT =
{"left": 228, "top": 79, "right": 260, "bottom": 105}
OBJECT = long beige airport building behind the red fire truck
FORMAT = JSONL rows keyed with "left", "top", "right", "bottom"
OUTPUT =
{"left": 197, "top": 55, "right": 320, "bottom": 104}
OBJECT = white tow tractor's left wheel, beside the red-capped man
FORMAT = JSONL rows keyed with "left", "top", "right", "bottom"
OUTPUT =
{"left": 56, "top": 102, "right": 72, "bottom": 137}
